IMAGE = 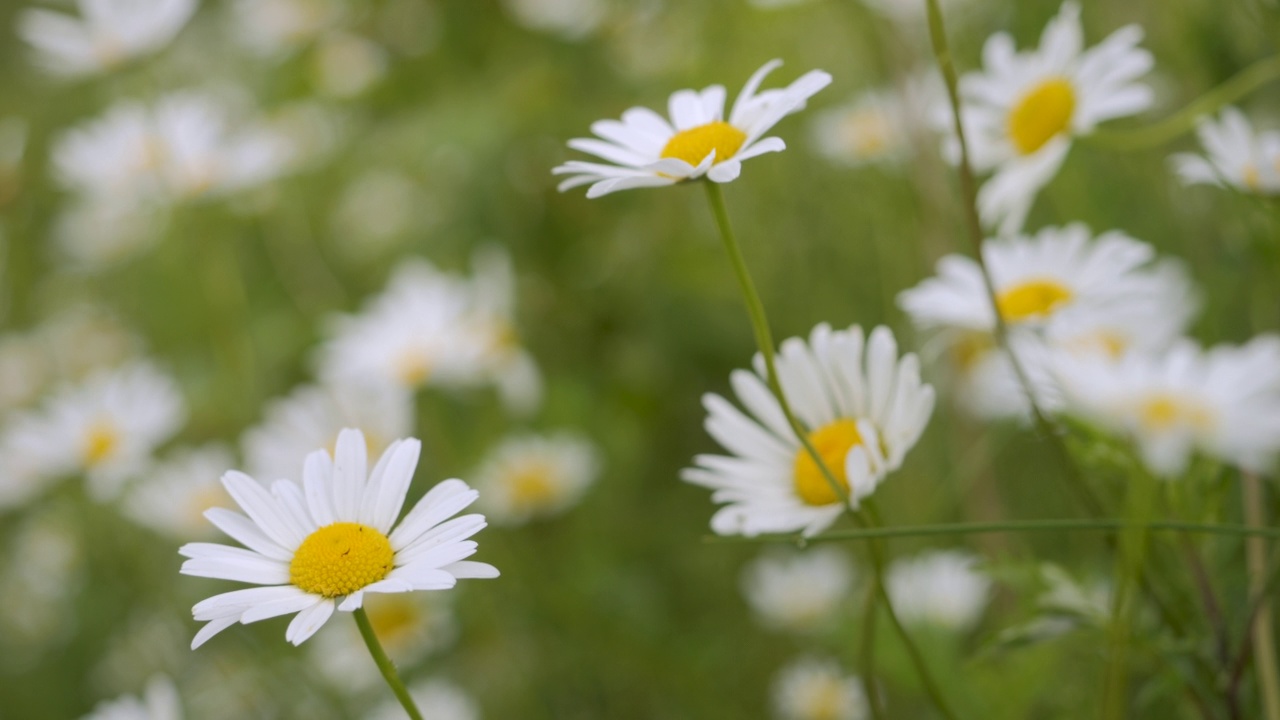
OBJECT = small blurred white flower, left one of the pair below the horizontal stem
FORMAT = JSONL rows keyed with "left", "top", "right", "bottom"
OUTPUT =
{"left": 742, "top": 547, "right": 855, "bottom": 632}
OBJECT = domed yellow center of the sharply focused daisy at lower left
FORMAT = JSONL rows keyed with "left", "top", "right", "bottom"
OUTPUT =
{"left": 289, "top": 523, "right": 396, "bottom": 597}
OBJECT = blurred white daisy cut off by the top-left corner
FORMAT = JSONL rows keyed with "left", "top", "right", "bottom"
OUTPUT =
{"left": 18, "top": 0, "right": 196, "bottom": 77}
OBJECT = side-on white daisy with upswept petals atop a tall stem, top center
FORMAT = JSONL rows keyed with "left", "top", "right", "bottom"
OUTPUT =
{"left": 552, "top": 60, "right": 831, "bottom": 197}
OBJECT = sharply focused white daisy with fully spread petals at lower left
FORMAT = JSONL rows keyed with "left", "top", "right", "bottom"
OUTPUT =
{"left": 180, "top": 429, "right": 498, "bottom": 648}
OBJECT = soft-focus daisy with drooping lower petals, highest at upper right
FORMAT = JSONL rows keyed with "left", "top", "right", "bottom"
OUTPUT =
{"left": 952, "top": 3, "right": 1155, "bottom": 234}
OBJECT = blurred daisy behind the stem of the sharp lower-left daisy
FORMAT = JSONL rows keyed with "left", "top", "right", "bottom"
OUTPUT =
{"left": 311, "top": 589, "right": 458, "bottom": 691}
